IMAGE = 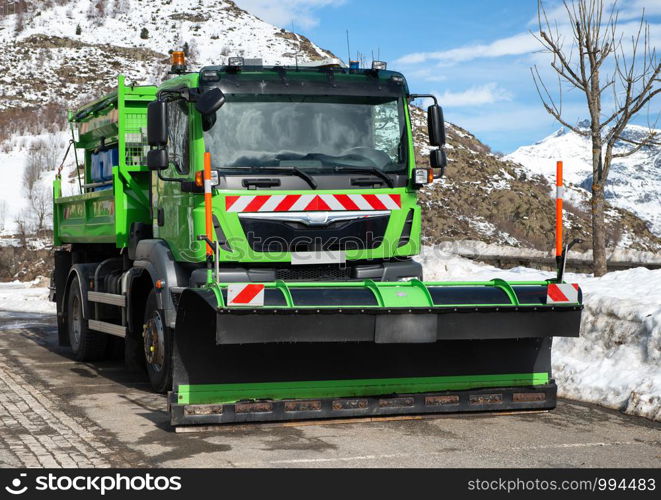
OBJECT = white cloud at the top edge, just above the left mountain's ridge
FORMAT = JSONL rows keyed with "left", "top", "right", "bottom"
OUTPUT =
{"left": 235, "top": 0, "right": 346, "bottom": 29}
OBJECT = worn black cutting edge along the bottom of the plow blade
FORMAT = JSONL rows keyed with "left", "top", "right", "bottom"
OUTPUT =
{"left": 168, "top": 381, "right": 557, "bottom": 426}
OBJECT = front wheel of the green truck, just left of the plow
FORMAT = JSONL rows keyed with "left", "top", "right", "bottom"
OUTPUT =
{"left": 142, "top": 289, "right": 172, "bottom": 393}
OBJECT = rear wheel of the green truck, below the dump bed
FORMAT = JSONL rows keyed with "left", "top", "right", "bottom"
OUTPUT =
{"left": 66, "top": 276, "right": 108, "bottom": 361}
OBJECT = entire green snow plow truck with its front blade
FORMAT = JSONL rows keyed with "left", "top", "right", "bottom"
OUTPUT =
{"left": 51, "top": 52, "right": 582, "bottom": 426}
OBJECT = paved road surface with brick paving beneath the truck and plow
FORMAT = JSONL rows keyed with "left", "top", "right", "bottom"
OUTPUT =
{"left": 0, "top": 312, "right": 661, "bottom": 467}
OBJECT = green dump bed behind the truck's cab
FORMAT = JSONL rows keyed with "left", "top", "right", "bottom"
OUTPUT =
{"left": 53, "top": 75, "right": 156, "bottom": 248}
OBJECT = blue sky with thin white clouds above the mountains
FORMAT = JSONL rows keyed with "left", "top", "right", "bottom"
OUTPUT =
{"left": 236, "top": 0, "right": 661, "bottom": 153}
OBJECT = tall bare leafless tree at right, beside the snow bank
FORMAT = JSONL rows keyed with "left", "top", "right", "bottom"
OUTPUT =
{"left": 531, "top": 0, "right": 661, "bottom": 276}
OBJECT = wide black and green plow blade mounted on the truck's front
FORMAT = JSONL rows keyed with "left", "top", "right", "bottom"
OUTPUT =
{"left": 169, "top": 280, "right": 582, "bottom": 425}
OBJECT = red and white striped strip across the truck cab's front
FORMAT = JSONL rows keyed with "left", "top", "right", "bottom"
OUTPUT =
{"left": 225, "top": 194, "right": 402, "bottom": 212}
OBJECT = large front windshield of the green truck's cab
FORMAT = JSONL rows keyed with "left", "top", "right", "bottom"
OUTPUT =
{"left": 204, "top": 95, "right": 406, "bottom": 174}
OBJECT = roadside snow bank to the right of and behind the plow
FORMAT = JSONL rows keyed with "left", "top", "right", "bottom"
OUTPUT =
{"left": 418, "top": 247, "right": 661, "bottom": 421}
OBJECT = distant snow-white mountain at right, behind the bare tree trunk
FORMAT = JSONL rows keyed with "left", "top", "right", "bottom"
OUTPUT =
{"left": 505, "top": 123, "right": 661, "bottom": 235}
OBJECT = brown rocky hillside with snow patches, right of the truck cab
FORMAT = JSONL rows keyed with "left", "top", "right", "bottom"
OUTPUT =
{"left": 412, "top": 108, "right": 661, "bottom": 251}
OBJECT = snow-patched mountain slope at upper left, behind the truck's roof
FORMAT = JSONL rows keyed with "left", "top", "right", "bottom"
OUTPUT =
{"left": 0, "top": 0, "right": 332, "bottom": 110}
